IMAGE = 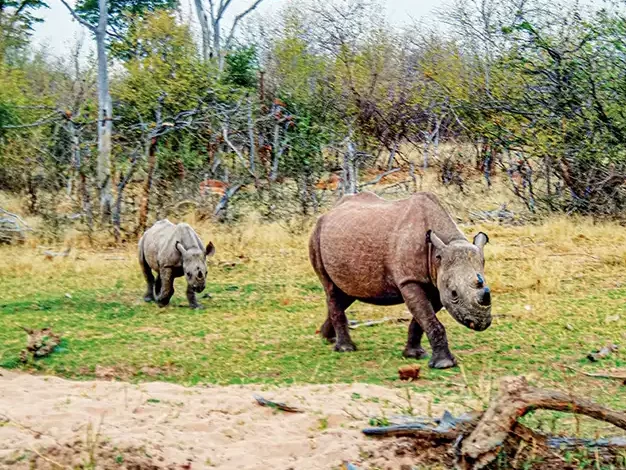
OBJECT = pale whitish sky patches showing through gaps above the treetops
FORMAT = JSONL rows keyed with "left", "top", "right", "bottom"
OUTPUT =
{"left": 29, "top": 0, "right": 442, "bottom": 56}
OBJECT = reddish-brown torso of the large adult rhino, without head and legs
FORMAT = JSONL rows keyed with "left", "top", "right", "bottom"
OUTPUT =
{"left": 319, "top": 193, "right": 463, "bottom": 303}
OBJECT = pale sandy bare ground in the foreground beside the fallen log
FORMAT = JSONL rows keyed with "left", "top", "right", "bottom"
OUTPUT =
{"left": 0, "top": 371, "right": 458, "bottom": 470}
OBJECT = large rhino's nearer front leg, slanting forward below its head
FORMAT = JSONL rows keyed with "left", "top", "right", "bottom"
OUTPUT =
{"left": 401, "top": 283, "right": 456, "bottom": 369}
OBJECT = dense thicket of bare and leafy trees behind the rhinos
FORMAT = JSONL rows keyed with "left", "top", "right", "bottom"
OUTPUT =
{"left": 0, "top": 0, "right": 626, "bottom": 240}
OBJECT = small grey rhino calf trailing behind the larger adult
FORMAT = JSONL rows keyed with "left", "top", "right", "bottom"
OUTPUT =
{"left": 139, "top": 219, "right": 215, "bottom": 308}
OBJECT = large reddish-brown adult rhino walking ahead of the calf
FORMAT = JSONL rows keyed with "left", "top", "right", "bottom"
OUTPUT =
{"left": 309, "top": 192, "right": 491, "bottom": 369}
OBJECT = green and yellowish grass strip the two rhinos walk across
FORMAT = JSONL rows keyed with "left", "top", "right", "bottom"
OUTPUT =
{"left": 0, "top": 216, "right": 626, "bottom": 436}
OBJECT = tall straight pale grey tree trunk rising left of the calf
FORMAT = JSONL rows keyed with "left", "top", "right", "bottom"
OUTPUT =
{"left": 96, "top": 0, "right": 113, "bottom": 224}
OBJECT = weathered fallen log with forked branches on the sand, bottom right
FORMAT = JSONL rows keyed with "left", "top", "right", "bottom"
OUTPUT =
{"left": 363, "top": 377, "right": 626, "bottom": 470}
